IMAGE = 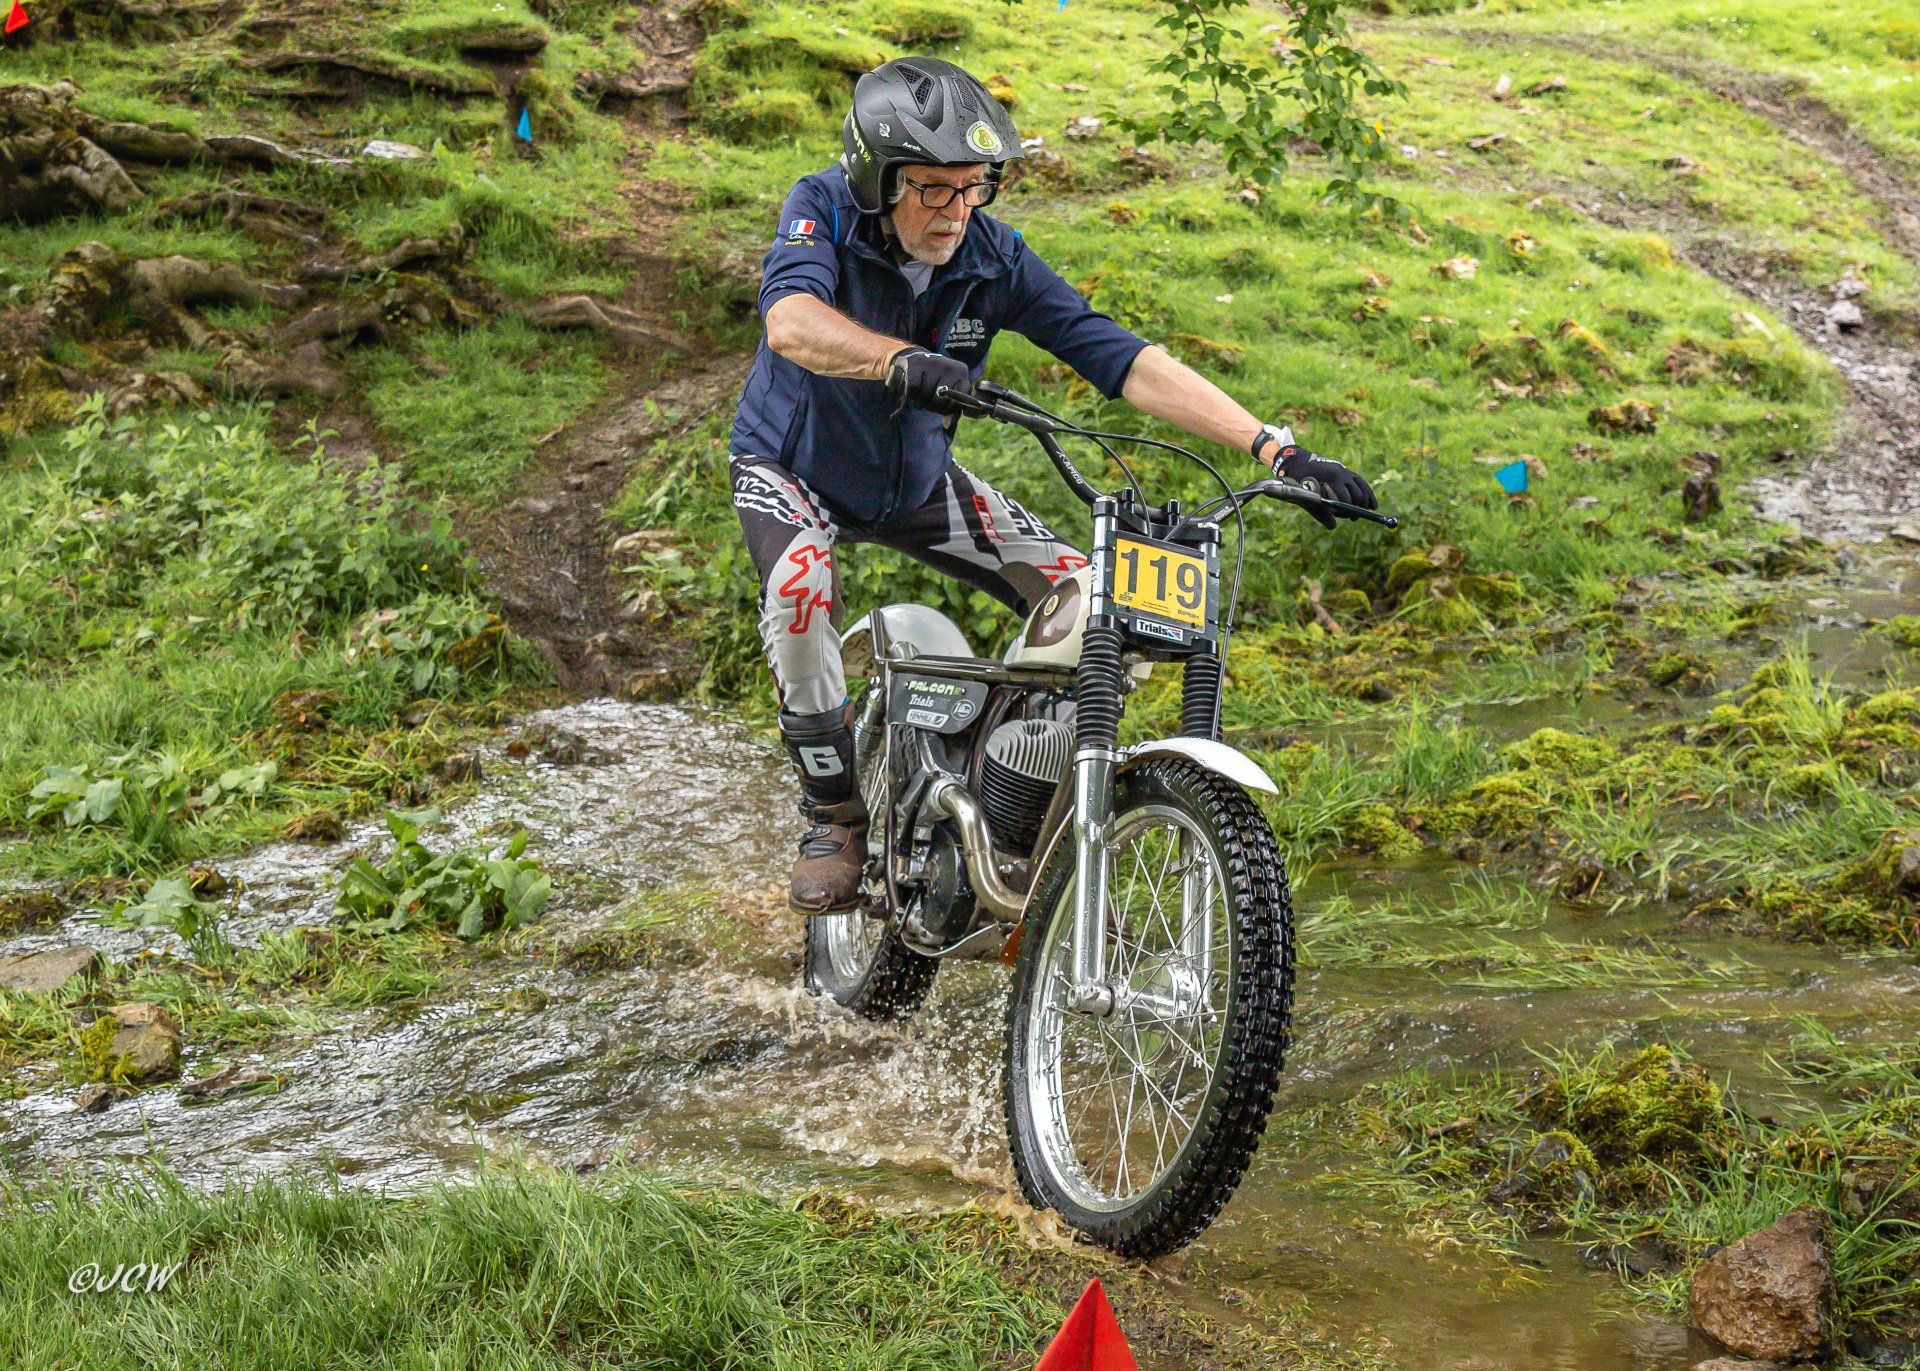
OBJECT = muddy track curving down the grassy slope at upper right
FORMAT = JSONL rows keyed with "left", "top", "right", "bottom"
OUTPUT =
{"left": 1428, "top": 27, "right": 1920, "bottom": 541}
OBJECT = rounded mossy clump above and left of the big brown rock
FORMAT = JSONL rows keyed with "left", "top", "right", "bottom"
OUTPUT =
{"left": 1524, "top": 1045, "right": 1732, "bottom": 1166}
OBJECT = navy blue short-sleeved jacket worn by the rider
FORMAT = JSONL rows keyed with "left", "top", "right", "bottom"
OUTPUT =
{"left": 732, "top": 165, "right": 1146, "bottom": 524}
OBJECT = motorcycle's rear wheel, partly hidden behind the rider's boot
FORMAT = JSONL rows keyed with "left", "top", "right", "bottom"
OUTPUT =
{"left": 801, "top": 682, "right": 941, "bottom": 1020}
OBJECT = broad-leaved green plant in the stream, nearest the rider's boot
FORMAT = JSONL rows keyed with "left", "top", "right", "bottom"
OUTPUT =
{"left": 334, "top": 808, "right": 553, "bottom": 939}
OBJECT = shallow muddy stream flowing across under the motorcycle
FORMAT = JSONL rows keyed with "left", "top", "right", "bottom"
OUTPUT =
{"left": 0, "top": 549, "right": 1920, "bottom": 1371}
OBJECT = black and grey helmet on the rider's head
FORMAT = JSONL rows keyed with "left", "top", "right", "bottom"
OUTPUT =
{"left": 841, "top": 58, "right": 1025, "bottom": 215}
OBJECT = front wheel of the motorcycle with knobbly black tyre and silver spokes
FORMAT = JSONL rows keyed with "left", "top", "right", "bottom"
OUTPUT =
{"left": 1006, "top": 758, "right": 1294, "bottom": 1258}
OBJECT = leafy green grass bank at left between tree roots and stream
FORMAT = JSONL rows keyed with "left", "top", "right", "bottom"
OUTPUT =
{"left": 0, "top": 401, "right": 532, "bottom": 876}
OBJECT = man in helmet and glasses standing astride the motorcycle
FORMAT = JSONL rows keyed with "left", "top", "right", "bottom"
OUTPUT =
{"left": 730, "top": 58, "right": 1375, "bottom": 914}
